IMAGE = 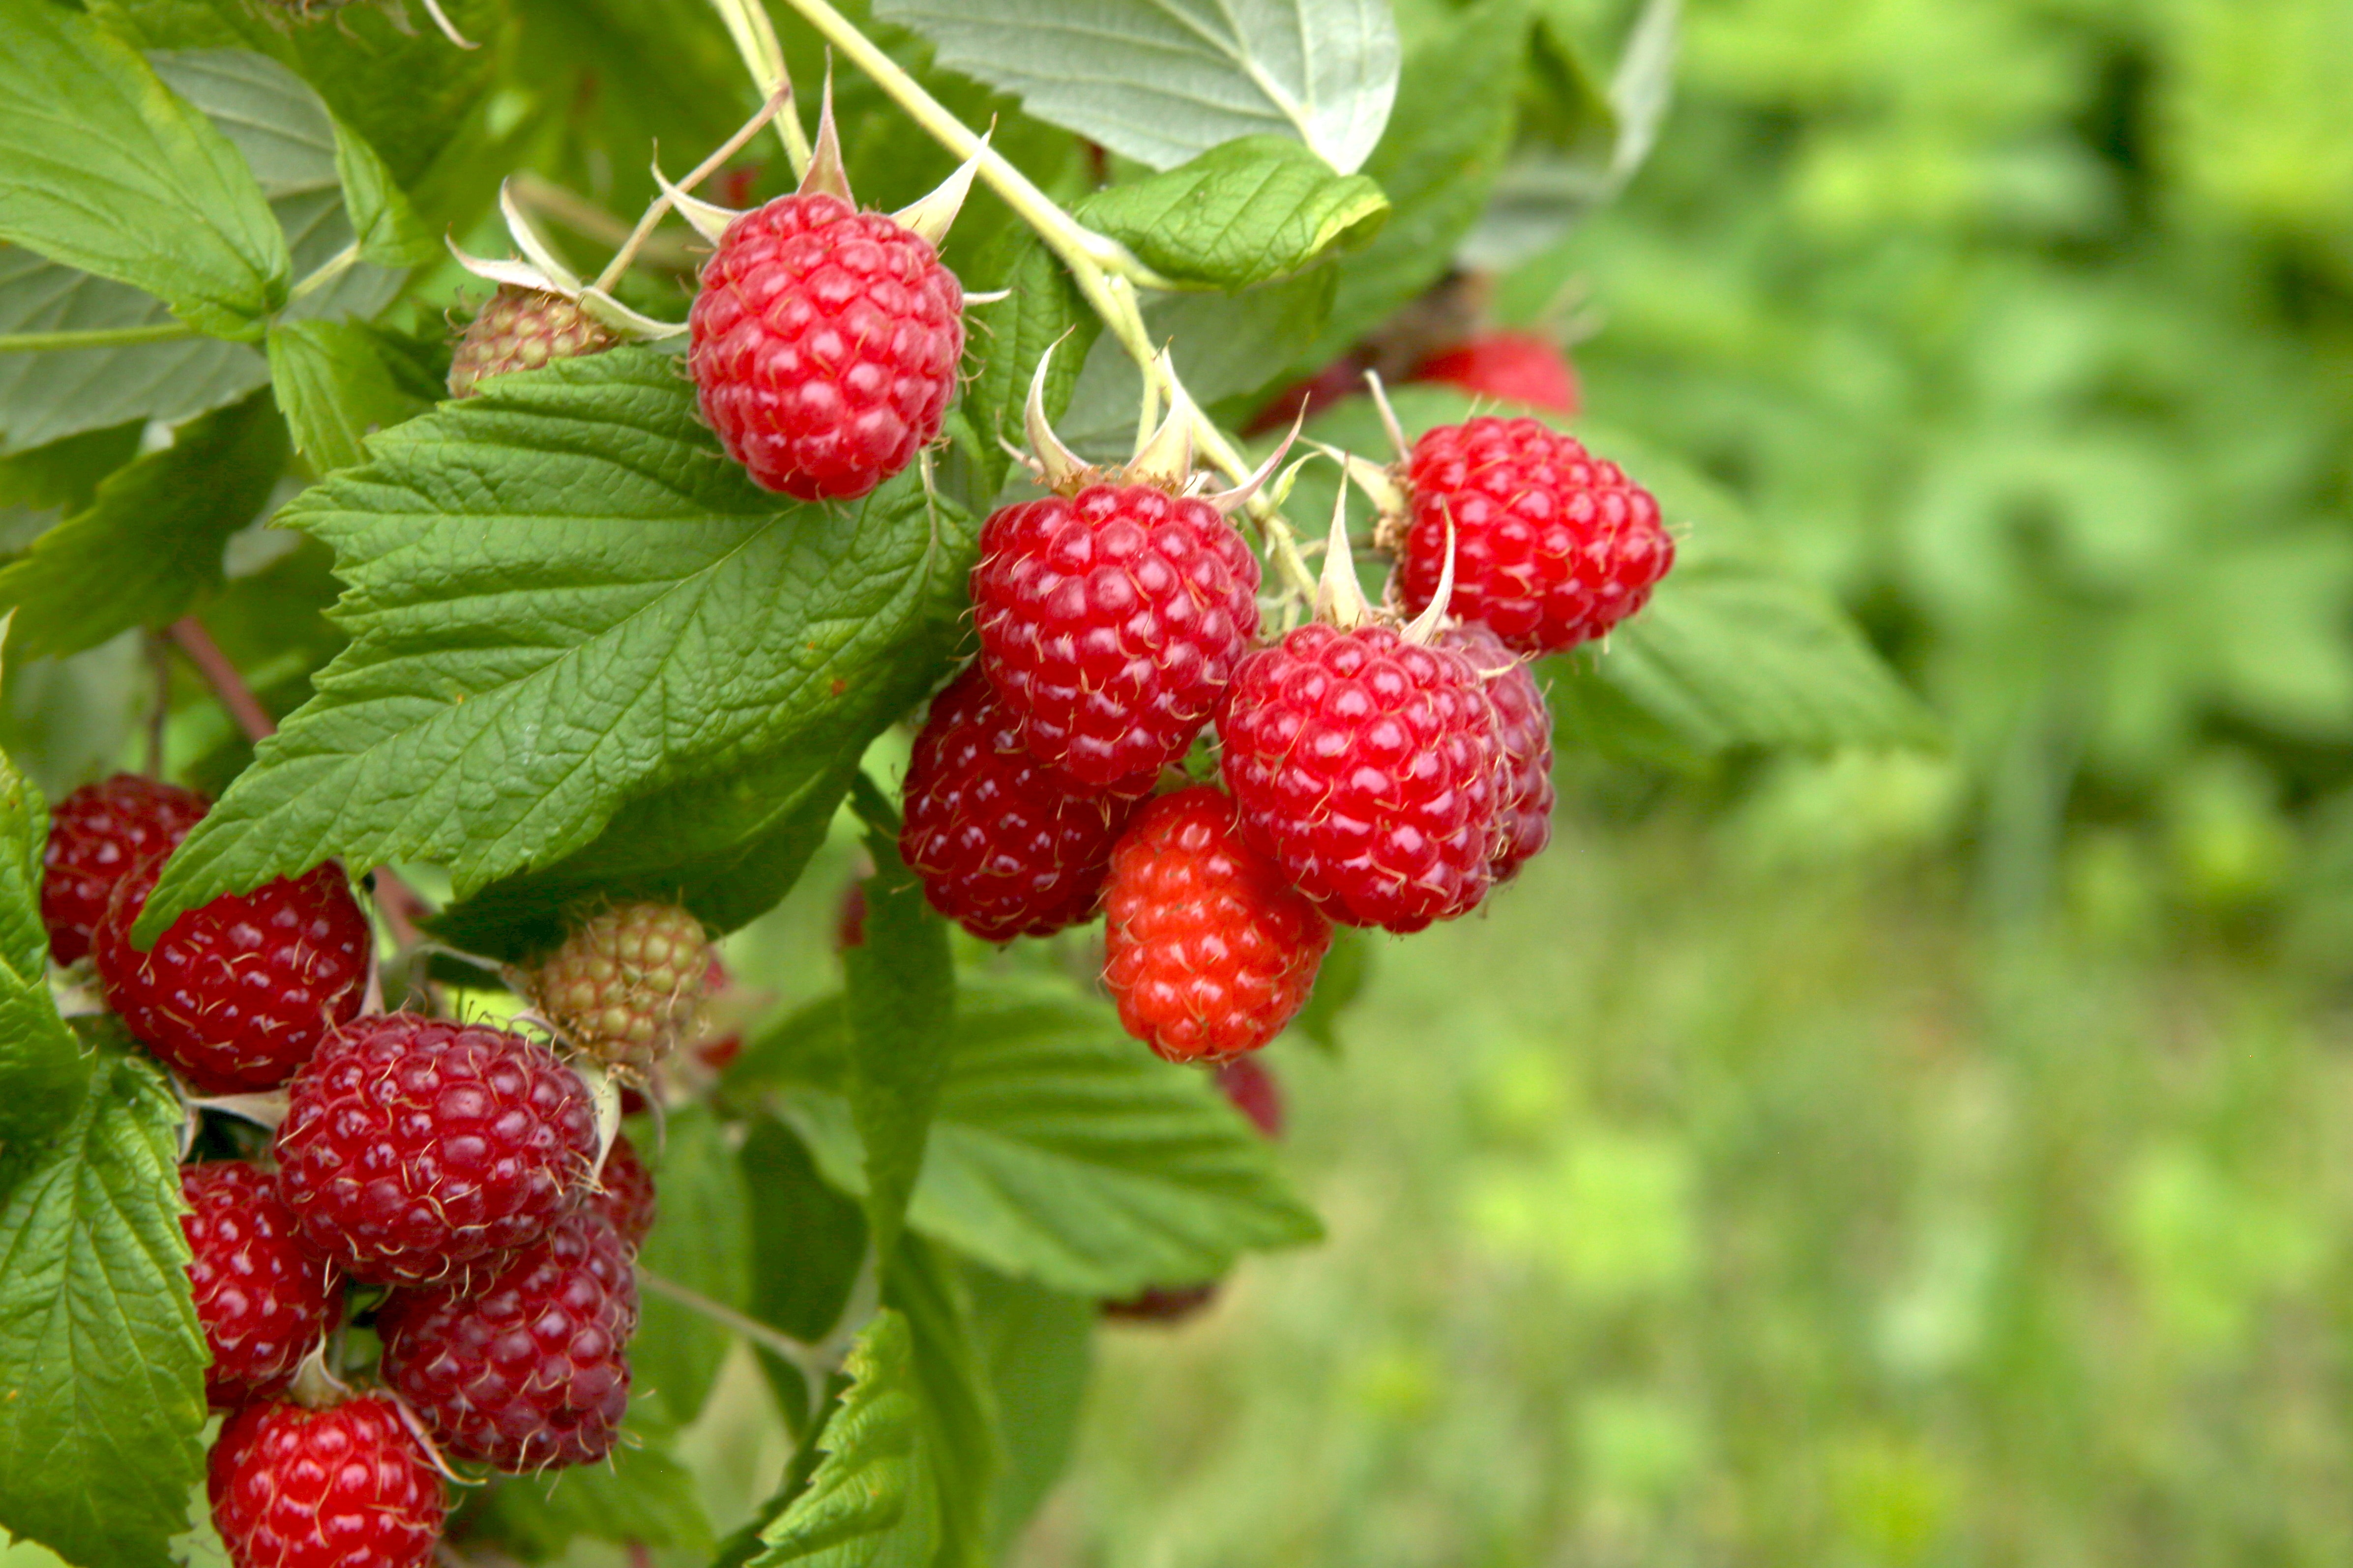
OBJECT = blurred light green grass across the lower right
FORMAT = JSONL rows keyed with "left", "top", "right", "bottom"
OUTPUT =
{"left": 1019, "top": 806, "right": 2353, "bottom": 1568}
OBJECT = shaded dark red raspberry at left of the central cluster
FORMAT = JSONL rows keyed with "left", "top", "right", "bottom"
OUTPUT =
{"left": 899, "top": 665, "right": 1153, "bottom": 943}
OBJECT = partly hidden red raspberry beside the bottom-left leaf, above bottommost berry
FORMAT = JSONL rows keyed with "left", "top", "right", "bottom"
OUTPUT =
{"left": 179, "top": 1159, "right": 344, "bottom": 1411}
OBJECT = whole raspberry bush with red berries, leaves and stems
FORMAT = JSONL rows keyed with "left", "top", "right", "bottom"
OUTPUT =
{"left": 0, "top": 0, "right": 1920, "bottom": 1568}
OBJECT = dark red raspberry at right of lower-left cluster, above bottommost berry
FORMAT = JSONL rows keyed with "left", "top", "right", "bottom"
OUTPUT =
{"left": 377, "top": 1211, "right": 638, "bottom": 1472}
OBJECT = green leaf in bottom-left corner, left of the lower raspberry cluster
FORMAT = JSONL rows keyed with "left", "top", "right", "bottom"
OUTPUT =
{"left": 0, "top": 1051, "right": 205, "bottom": 1566}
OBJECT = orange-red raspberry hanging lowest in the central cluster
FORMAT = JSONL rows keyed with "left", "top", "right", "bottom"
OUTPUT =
{"left": 1104, "top": 785, "right": 1332, "bottom": 1063}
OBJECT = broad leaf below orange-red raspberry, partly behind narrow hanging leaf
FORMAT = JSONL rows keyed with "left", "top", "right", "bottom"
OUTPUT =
{"left": 758, "top": 985, "right": 1323, "bottom": 1298}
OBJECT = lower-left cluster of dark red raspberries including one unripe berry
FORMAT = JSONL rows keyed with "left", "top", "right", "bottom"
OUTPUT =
{"left": 42, "top": 778, "right": 673, "bottom": 1568}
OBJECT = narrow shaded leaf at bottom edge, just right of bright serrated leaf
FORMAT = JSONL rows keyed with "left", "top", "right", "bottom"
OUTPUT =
{"left": 882, "top": 1237, "right": 1005, "bottom": 1568}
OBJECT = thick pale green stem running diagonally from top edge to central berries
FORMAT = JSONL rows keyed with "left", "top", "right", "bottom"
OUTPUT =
{"left": 767, "top": 0, "right": 1315, "bottom": 600}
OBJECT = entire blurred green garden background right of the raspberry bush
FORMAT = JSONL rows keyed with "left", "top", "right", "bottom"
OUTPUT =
{"left": 1017, "top": 0, "right": 2353, "bottom": 1568}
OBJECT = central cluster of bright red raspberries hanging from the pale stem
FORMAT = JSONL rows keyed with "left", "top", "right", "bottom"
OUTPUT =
{"left": 927, "top": 400, "right": 1673, "bottom": 1063}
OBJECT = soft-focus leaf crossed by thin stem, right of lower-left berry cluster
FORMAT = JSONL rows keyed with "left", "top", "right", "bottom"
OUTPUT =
{"left": 628, "top": 1105, "right": 751, "bottom": 1427}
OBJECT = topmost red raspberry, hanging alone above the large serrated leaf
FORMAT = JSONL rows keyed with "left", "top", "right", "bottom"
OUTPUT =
{"left": 687, "top": 190, "right": 965, "bottom": 501}
